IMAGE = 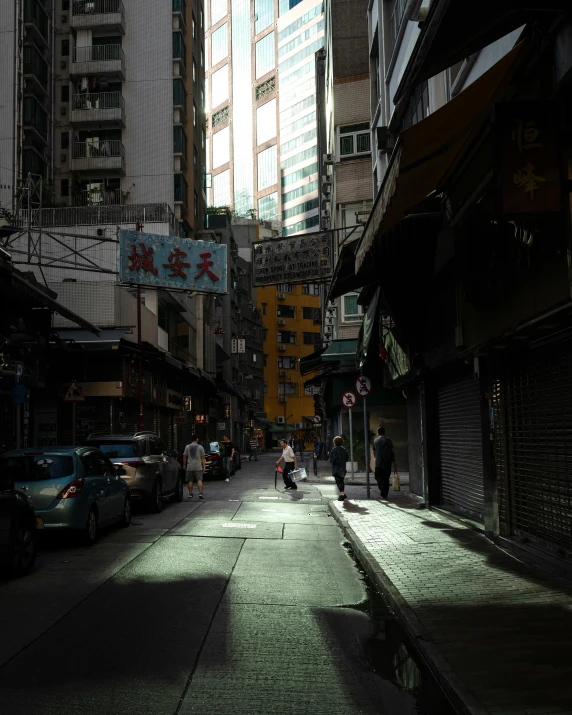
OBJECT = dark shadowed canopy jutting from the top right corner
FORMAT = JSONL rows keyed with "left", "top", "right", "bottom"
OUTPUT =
{"left": 394, "top": 0, "right": 571, "bottom": 103}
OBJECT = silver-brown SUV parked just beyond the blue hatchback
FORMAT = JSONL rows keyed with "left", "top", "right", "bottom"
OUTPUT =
{"left": 84, "top": 432, "right": 184, "bottom": 513}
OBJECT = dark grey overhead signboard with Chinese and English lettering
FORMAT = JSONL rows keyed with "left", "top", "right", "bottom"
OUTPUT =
{"left": 252, "top": 231, "right": 334, "bottom": 286}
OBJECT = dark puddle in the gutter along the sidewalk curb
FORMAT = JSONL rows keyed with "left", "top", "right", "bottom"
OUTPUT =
{"left": 344, "top": 542, "right": 457, "bottom": 715}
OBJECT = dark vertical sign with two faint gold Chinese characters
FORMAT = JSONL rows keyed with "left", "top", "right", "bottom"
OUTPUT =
{"left": 496, "top": 102, "right": 561, "bottom": 214}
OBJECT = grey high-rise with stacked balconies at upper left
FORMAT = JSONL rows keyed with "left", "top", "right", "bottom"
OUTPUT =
{"left": 0, "top": 0, "right": 206, "bottom": 235}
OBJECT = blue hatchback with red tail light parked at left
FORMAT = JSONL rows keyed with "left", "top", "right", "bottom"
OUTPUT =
{"left": 0, "top": 447, "right": 131, "bottom": 544}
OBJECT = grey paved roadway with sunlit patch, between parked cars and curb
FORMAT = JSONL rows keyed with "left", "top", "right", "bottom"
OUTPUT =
{"left": 0, "top": 455, "right": 428, "bottom": 715}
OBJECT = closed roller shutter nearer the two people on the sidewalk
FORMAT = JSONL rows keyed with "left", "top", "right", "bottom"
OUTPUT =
{"left": 438, "top": 376, "right": 484, "bottom": 521}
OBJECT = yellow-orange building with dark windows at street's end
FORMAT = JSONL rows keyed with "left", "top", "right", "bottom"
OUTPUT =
{"left": 257, "top": 283, "right": 321, "bottom": 437}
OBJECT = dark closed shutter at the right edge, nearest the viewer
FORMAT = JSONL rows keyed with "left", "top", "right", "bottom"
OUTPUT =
{"left": 506, "top": 342, "right": 572, "bottom": 550}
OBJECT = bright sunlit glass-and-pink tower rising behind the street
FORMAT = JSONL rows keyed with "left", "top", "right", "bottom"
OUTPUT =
{"left": 206, "top": 0, "right": 324, "bottom": 236}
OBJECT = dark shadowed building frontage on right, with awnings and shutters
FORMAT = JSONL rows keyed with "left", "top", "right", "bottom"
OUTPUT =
{"left": 340, "top": 0, "right": 572, "bottom": 568}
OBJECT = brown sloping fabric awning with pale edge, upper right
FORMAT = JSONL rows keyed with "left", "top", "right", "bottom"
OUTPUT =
{"left": 355, "top": 42, "right": 527, "bottom": 274}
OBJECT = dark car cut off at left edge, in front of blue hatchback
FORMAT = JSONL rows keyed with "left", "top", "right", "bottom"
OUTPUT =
{"left": 0, "top": 470, "right": 36, "bottom": 576}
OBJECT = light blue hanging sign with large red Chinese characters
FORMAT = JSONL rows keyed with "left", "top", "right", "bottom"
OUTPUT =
{"left": 119, "top": 230, "right": 228, "bottom": 293}
